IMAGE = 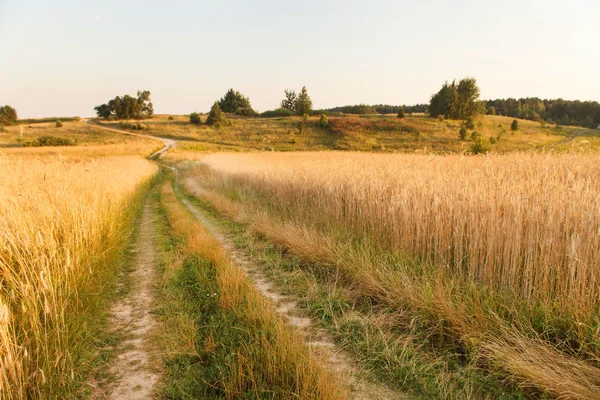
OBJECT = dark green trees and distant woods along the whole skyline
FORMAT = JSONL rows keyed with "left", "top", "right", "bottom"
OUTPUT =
{"left": 91, "top": 83, "right": 600, "bottom": 128}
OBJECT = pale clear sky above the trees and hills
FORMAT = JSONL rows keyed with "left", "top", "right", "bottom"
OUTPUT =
{"left": 0, "top": 0, "right": 600, "bottom": 117}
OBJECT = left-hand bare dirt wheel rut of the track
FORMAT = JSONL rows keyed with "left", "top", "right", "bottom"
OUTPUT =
{"left": 92, "top": 200, "right": 161, "bottom": 400}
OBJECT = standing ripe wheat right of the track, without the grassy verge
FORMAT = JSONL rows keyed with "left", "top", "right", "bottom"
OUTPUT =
{"left": 198, "top": 153, "right": 600, "bottom": 322}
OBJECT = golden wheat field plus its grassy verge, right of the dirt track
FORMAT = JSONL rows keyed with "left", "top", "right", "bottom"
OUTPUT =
{"left": 184, "top": 153, "right": 600, "bottom": 398}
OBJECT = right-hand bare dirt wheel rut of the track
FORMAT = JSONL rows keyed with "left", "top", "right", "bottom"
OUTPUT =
{"left": 176, "top": 193, "right": 407, "bottom": 400}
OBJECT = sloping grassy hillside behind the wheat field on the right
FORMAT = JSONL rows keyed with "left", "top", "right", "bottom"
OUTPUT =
{"left": 98, "top": 115, "right": 600, "bottom": 153}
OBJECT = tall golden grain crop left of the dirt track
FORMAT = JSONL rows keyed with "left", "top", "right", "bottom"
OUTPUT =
{"left": 0, "top": 157, "right": 156, "bottom": 399}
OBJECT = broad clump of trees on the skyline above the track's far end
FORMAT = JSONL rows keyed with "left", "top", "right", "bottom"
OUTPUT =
{"left": 94, "top": 90, "right": 154, "bottom": 119}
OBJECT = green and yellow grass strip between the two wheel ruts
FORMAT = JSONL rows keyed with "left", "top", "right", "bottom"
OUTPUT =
{"left": 161, "top": 184, "right": 347, "bottom": 399}
